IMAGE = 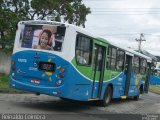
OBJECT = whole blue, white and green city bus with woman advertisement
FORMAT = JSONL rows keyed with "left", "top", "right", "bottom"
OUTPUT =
{"left": 10, "top": 21, "right": 151, "bottom": 106}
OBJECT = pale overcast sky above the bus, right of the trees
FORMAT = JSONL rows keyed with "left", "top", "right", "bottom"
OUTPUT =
{"left": 83, "top": 0, "right": 160, "bottom": 56}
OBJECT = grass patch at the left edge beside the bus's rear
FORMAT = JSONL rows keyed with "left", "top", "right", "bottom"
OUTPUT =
{"left": 0, "top": 75, "right": 21, "bottom": 93}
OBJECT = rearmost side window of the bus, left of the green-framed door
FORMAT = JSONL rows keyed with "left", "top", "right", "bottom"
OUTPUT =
{"left": 76, "top": 35, "right": 92, "bottom": 65}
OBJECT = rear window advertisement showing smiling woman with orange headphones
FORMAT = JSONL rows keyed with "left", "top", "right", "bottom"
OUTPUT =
{"left": 20, "top": 24, "right": 66, "bottom": 52}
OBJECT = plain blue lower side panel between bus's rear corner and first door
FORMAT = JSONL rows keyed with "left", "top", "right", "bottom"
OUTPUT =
{"left": 62, "top": 65, "right": 92, "bottom": 101}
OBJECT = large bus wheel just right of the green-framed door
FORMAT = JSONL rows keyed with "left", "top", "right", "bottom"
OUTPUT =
{"left": 101, "top": 86, "right": 112, "bottom": 107}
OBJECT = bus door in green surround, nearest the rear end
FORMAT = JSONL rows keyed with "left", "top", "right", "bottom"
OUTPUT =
{"left": 91, "top": 44, "right": 106, "bottom": 99}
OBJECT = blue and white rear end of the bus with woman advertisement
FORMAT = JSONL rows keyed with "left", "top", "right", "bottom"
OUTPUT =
{"left": 10, "top": 21, "right": 69, "bottom": 97}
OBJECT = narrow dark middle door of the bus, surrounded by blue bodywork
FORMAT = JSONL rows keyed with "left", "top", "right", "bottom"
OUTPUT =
{"left": 124, "top": 55, "right": 132, "bottom": 96}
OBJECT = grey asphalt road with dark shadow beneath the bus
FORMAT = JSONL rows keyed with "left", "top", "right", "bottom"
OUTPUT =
{"left": 0, "top": 93, "right": 160, "bottom": 120}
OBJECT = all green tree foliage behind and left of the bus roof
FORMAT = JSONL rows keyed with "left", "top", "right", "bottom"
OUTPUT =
{"left": 0, "top": 0, "right": 91, "bottom": 51}
